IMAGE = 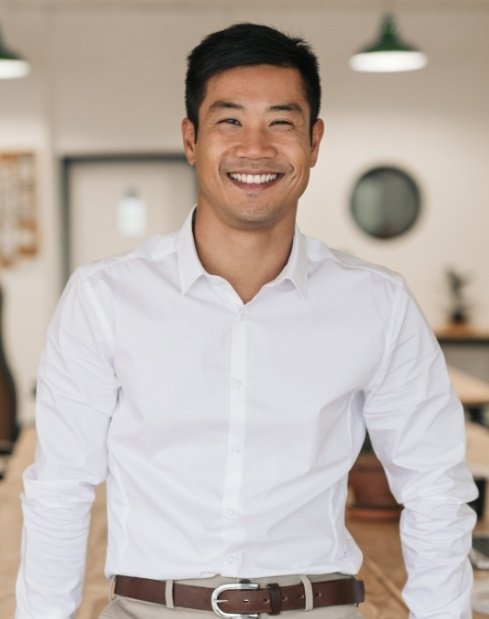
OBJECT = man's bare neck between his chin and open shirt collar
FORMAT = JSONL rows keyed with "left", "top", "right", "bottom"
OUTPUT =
{"left": 194, "top": 210, "right": 294, "bottom": 303}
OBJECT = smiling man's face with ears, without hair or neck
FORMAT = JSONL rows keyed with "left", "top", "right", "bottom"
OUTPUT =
{"left": 182, "top": 65, "right": 323, "bottom": 230}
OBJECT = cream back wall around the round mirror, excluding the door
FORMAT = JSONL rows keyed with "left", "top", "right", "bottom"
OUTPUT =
{"left": 0, "top": 0, "right": 489, "bottom": 419}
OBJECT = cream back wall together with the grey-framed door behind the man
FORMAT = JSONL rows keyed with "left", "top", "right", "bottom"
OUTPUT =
{"left": 0, "top": 0, "right": 489, "bottom": 422}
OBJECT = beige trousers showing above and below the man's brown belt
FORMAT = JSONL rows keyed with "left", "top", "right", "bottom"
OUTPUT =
{"left": 99, "top": 574, "right": 362, "bottom": 619}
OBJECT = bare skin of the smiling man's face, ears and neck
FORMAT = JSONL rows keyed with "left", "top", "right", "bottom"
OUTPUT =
{"left": 183, "top": 64, "right": 323, "bottom": 302}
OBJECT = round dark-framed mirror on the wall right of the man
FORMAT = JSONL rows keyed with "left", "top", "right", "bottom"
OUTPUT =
{"left": 350, "top": 166, "right": 421, "bottom": 239}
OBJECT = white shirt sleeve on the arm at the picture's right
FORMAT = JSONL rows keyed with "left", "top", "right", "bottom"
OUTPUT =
{"left": 365, "top": 286, "right": 477, "bottom": 619}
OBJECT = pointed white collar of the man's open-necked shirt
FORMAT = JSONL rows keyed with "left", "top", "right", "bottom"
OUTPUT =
{"left": 176, "top": 207, "right": 308, "bottom": 296}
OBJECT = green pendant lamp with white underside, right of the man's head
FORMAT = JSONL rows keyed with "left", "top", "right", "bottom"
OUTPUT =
{"left": 350, "top": 14, "right": 428, "bottom": 73}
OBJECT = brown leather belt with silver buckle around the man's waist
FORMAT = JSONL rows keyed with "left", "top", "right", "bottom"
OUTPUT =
{"left": 114, "top": 576, "right": 365, "bottom": 618}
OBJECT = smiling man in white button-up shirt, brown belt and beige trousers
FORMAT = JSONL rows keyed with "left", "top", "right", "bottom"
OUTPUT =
{"left": 16, "top": 24, "right": 475, "bottom": 619}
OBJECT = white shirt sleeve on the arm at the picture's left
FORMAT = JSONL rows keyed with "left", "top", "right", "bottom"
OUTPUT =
{"left": 15, "top": 271, "right": 118, "bottom": 619}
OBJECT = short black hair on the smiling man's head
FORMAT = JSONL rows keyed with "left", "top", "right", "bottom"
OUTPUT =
{"left": 185, "top": 23, "right": 321, "bottom": 135}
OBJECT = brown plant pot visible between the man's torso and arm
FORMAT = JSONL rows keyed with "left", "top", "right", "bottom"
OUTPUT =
{"left": 348, "top": 434, "right": 402, "bottom": 521}
